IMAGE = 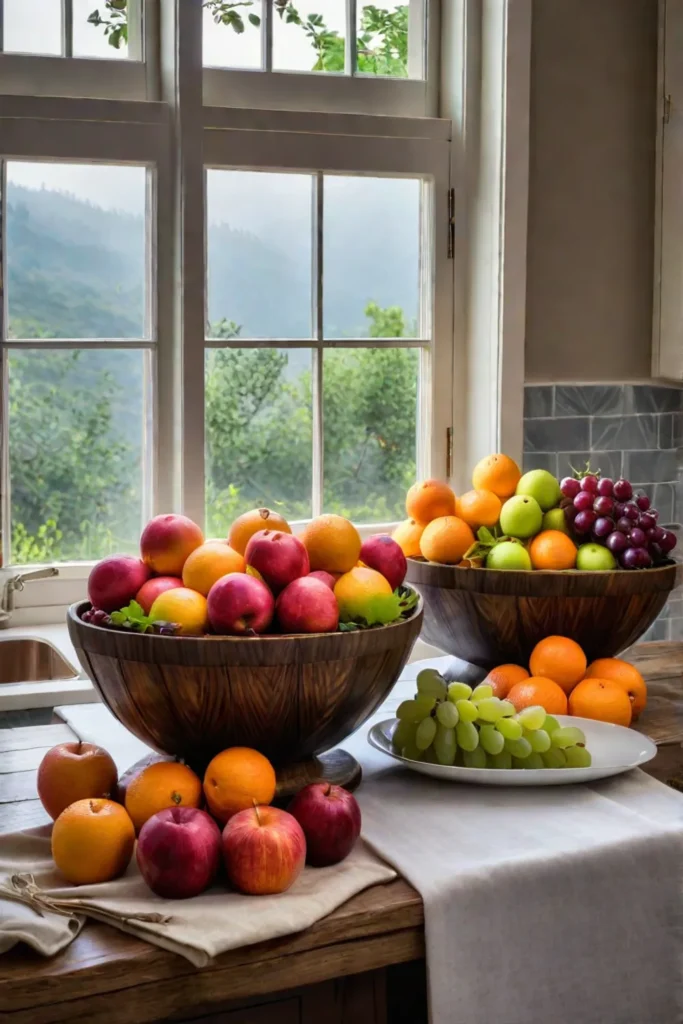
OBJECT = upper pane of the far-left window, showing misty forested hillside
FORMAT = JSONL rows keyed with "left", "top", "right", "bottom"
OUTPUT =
{"left": 7, "top": 161, "right": 146, "bottom": 339}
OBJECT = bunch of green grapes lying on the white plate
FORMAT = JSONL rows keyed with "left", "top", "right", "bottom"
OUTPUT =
{"left": 391, "top": 669, "right": 591, "bottom": 768}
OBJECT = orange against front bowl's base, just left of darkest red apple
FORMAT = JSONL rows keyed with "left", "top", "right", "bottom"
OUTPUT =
{"left": 204, "top": 746, "right": 275, "bottom": 823}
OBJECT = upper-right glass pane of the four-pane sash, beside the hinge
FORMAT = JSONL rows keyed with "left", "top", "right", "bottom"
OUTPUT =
{"left": 324, "top": 175, "right": 422, "bottom": 338}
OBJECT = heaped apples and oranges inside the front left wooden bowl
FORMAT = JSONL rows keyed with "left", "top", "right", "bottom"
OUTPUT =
{"left": 83, "top": 509, "right": 418, "bottom": 636}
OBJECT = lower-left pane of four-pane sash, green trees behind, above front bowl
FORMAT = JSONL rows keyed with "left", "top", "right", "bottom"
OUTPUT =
{"left": 206, "top": 348, "right": 312, "bottom": 537}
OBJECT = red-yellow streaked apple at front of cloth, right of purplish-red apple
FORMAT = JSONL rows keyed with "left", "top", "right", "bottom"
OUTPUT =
{"left": 222, "top": 807, "right": 306, "bottom": 896}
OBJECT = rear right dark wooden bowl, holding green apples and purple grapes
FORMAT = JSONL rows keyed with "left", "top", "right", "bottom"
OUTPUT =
{"left": 405, "top": 558, "right": 677, "bottom": 671}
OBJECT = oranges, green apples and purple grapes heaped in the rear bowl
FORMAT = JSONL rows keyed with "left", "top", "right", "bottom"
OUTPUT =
{"left": 393, "top": 455, "right": 676, "bottom": 571}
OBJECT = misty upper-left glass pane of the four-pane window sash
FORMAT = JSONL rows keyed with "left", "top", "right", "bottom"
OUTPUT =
{"left": 207, "top": 170, "right": 313, "bottom": 338}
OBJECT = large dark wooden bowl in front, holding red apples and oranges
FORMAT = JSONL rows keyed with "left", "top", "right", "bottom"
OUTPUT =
{"left": 68, "top": 602, "right": 423, "bottom": 767}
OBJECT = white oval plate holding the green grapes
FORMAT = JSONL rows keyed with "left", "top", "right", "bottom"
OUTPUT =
{"left": 368, "top": 715, "right": 657, "bottom": 785}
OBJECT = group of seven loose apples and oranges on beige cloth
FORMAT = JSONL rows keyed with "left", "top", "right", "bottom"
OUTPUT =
{"left": 38, "top": 743, "right": 360, "bottom": 899}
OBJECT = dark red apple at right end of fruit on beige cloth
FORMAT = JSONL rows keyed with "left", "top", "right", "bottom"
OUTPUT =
{"left": 289, "top": 782, "right": 360, "bottom": 867}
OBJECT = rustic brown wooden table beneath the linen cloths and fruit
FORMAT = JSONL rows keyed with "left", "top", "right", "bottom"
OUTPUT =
{"left": 0, "top": 643, "right": 683, "bottom": 1024}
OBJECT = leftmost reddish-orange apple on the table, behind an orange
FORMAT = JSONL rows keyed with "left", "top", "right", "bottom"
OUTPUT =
{"left": 37, "top": 741, "right": 119, "bottom": 820}
